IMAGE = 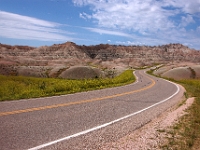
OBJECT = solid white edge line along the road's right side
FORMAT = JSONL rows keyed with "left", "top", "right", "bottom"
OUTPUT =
{"left": 28, "top": 71, "right": 180, "bottom": 150}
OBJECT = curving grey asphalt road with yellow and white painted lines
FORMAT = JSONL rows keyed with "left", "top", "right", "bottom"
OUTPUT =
{"left": 0, "top": 70, "right": 183, "bottom": 150}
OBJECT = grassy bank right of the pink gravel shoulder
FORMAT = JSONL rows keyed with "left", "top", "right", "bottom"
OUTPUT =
{"left": 149, "top": 68, "right": 200, "bottom": 150}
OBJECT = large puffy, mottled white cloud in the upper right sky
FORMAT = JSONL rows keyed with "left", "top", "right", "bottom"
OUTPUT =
{"left": 73, "top": 0, "right": 200, "bottom": 33}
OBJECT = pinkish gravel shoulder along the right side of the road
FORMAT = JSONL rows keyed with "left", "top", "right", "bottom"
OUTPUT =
{"left": 102, "top": 86, "right": 194, "bottom": 150}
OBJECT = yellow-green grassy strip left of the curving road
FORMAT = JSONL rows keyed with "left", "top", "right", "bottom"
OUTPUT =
{"left": 0, "top": 70, "right": 135, "bottom": 101}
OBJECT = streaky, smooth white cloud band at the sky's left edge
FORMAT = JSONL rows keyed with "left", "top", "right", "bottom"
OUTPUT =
{"left": 0, "top": 11, "right": 72, "bottom": 41}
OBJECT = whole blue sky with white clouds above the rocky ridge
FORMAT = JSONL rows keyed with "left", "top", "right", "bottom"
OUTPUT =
{"left": 0, "top": 0, "right": 200, "bottom": 50}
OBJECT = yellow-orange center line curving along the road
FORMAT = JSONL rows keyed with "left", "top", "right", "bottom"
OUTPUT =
{"left": 0, "top": 74, "right": 155, "bottom": 117}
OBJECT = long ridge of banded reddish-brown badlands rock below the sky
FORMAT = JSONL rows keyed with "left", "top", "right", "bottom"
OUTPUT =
{"left": 0, "top": 42, "right": 200, "bottom": 78}
